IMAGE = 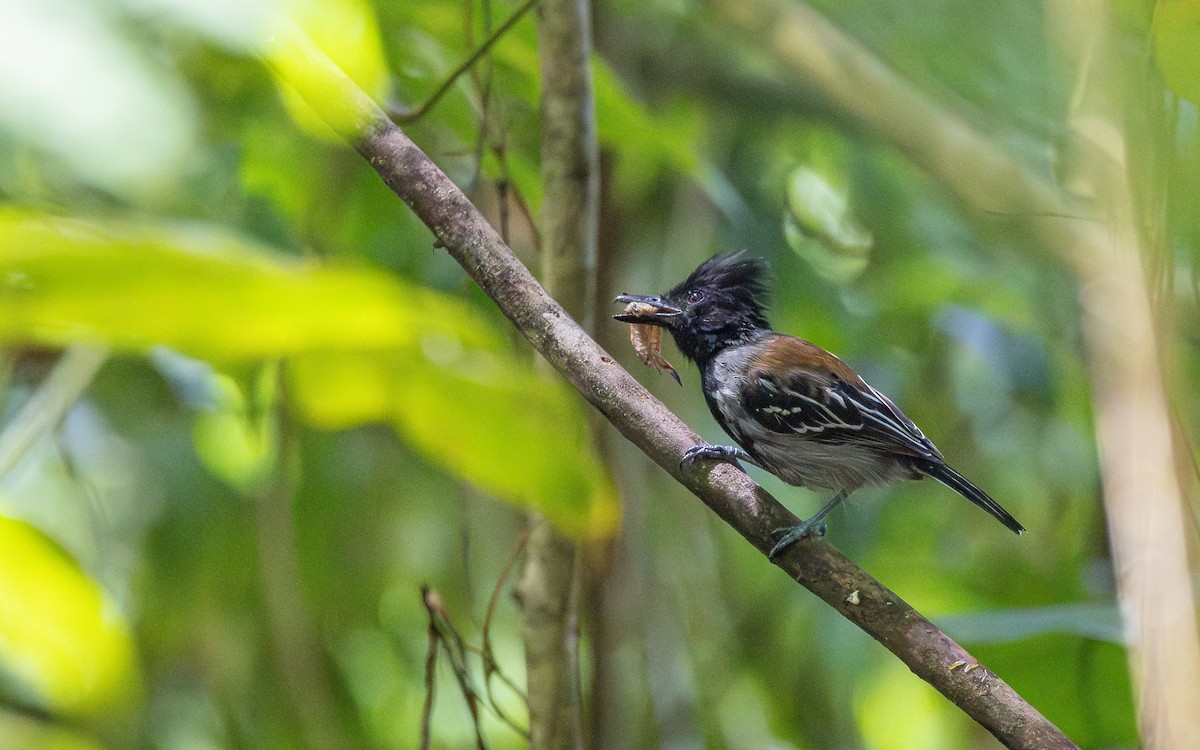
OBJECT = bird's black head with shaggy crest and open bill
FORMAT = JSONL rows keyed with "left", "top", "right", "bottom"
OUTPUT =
{"left": 613, "top": 250, "right": 770, "bottom": 360}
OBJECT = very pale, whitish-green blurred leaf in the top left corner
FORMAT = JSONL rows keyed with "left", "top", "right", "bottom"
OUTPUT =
{"left": 0, "top": 0, "right": 196, "bottom": 203}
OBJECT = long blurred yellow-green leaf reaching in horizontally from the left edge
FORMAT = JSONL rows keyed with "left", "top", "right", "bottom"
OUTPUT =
{"left": 0, "top": 212, "right": 463, "bottom": 361}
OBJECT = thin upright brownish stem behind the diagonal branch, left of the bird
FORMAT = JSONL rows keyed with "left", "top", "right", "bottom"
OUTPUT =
{"left": 518, "top": 0, "right": 599, "bottom": 750}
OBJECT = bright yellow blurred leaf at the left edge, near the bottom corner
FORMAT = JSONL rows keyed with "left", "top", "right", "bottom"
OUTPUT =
{"left": 0, "top": 517, "right": 142, "bottom": 719}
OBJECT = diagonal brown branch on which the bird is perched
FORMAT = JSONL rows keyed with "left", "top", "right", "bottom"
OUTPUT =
{"left": 268, "top": 20, "right": 1075, "bottom": 749}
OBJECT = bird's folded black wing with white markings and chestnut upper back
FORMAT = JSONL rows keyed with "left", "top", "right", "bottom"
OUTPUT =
{"left": 742, "top": 336, "right": 941, "bottom": 458}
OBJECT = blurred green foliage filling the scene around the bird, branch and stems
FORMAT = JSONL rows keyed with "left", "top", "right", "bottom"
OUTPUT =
{"left": 0, "top": 0, "right": 1200, "bottom": 750}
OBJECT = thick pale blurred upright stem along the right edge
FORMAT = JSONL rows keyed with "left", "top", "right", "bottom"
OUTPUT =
{"left": 1048, "top": 0, "right": 1200, "bottom": 748}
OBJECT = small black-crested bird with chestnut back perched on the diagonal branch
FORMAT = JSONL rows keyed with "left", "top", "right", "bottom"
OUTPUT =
{"left": 613, "top": 250, "right": 1025, "bottom": 559}
